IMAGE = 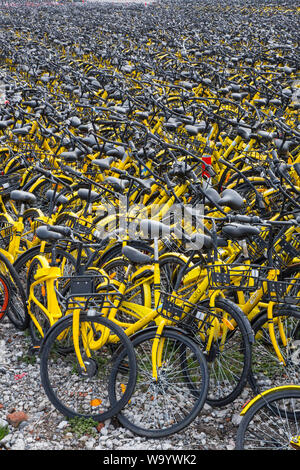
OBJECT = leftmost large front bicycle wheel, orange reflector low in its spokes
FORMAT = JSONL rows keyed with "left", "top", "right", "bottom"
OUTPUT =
{"left": 40, "top": 314, "right": 136, "bottom": 422}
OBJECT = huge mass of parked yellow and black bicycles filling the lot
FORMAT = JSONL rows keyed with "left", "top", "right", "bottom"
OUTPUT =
{"left": 0, "top": 0, "right": 300, "bottom": 446}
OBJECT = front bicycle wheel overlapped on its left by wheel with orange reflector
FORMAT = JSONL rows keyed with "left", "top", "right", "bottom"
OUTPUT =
{"left": 110, "top": 328, "right": 209, "bottom": 438}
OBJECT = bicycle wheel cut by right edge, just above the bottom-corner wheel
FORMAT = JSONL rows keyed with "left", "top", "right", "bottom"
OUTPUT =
{"left": 249, "top": 306, "right": 300, "bottom": 393}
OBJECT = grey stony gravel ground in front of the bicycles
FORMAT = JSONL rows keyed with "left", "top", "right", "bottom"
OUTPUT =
{"left": 0, "top": 318, "right": 255, "bottom": 451}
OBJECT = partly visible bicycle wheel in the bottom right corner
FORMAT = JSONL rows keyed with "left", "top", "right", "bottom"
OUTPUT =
{"left": 236, "top": 387, "right": 300, "bottom": 450}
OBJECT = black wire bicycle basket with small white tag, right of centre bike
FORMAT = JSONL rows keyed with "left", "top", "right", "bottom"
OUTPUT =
{"left": 206, "top": 264, "right": 262, "bottom": 292}
